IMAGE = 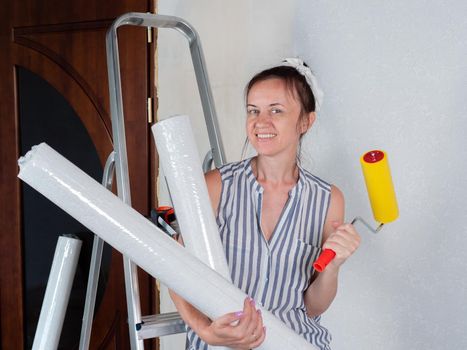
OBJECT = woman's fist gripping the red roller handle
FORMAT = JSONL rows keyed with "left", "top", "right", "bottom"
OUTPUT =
{"left": 323, "top": 222, "right": 361, "bottom": 268}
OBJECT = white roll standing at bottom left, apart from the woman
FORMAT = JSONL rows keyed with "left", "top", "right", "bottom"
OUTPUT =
{"left": 32, "top": 236, "right": 81, "bottom": 350}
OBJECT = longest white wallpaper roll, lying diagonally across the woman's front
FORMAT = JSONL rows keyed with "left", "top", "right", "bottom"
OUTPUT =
{"left": 18, "top": 143, "right": 316, "bottom": 350}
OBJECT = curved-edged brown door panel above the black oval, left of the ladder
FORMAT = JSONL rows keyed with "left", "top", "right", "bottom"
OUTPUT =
{"left": 13, "top": 21, "right": 115, "bottom": 139}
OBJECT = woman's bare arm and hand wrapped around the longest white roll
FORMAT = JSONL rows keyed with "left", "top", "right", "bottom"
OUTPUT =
{"left": 169, "top": 169, "right": 265, "bottom": 349}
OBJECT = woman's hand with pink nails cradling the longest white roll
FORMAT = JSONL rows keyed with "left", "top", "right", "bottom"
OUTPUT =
{"left": 199, "top": 298, "right": 266, "bottom": 350}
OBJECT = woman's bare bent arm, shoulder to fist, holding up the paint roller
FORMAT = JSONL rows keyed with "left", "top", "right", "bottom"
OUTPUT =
{"left": 304, "top": 186, "right": 360, "bottom": 317}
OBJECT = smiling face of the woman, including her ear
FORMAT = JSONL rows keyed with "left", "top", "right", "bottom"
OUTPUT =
{"left": 246, "top": 78, "right": 314, "bottom": 158}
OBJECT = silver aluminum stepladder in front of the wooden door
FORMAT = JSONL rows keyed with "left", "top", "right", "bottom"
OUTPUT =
{"left": 79, "top": 12, "right": 225, "bottom": 350}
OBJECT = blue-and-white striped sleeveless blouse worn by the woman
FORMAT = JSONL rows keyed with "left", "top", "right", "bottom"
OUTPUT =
{"left": 187, "top": 158, "right": 331, "bottom": 350}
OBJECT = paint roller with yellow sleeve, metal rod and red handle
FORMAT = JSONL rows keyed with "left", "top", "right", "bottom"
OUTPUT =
{"left": 313, "top": 150, "right": 399, "bottom": 272}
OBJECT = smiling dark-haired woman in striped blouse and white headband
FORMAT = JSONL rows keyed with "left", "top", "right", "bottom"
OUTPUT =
{"left": 171, "top": 59, "right": 360, "bottom": 350}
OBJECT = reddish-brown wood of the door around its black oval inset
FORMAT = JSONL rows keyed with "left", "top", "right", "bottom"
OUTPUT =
{"left": 0, "top": 0, "right": 158, "bottom": 350}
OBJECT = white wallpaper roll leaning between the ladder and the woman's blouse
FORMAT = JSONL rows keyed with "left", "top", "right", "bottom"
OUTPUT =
{"left": 151, "top": 115, "right": 230, "bottom": 280}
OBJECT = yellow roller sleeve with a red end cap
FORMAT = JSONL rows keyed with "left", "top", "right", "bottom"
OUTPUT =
{"left": 360, "top": 150, "right": 399, "bottom": 224}
